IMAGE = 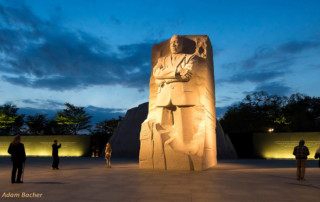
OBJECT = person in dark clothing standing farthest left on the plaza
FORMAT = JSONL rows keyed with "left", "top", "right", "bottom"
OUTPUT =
{"left": 8, "top": 135, "right": 26, "bottom": 183}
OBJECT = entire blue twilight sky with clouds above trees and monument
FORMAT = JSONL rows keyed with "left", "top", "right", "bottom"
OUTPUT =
{"left": 0, "top": 0, "right": 320, "bottom": 117}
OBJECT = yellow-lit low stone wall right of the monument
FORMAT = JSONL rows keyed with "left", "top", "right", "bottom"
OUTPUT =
{"left": 253, "top": 132, "right": 320, "bottom": 159}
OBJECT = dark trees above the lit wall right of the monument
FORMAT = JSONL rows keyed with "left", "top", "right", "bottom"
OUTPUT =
{"left": 220, "top": 92, "right": 320, "bottom": 134}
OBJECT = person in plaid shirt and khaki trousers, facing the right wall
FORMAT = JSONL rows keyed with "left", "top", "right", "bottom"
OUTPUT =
{"left": 293, "top": 140, "right": 310, "bottom": 180}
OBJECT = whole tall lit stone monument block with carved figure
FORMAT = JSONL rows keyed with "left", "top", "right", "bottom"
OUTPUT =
{"left": 139, "top": 35, "right": 217, "bottom": 170}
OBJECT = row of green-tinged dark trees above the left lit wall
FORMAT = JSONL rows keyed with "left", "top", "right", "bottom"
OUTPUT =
{"left": 0, "top": 103, "right": 122, "bottom": 139}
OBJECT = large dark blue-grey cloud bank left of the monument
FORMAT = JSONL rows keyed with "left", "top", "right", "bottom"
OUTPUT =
{"left": 0, "top": 5, "right": 155, "bottom": 91}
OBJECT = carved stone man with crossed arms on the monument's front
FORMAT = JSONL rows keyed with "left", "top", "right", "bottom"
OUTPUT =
{"left": 153, "top": 35, "right": 204, "bottom": 166}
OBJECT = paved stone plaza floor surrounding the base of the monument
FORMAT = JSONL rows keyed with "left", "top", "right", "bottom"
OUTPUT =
{"left": 0, "top": 157, "right": 320, "bottom": 202}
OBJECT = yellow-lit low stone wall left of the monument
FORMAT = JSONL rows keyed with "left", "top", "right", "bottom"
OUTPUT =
{"left": 0, "top": 135, "right": 90, "bottom": 157}
